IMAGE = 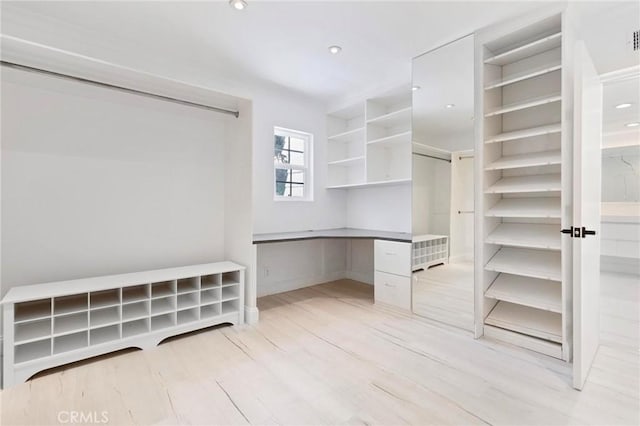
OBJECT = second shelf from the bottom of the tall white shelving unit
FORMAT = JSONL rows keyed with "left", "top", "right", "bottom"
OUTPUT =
{"left": 484, "top": 274, "right": 562, "bottom": 313}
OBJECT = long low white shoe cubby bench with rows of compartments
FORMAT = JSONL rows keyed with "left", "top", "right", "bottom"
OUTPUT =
{"left": 1, "top": 262, "right": 245, "bottom": 388}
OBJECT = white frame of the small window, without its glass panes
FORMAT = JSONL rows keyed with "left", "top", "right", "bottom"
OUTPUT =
{"left": 271, "top": 126, "right": 313, "bottom": 202}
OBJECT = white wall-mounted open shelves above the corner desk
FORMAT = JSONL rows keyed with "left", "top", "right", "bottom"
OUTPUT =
{"left": 327, "top": 88, "right": 411, "bottom": 189}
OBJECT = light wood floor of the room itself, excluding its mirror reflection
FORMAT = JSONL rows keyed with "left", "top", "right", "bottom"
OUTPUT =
{"left": 1, "top": 276, "right": 640, "bottom": 425}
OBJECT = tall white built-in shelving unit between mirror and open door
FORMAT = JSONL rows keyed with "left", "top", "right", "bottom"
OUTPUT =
{"left": 476, "top": 14, "right": 571, "bottom": 360}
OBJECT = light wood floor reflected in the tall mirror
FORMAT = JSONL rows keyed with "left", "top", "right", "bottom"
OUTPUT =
{"left": 412, "top": 262, "right": 473, "bottom": 332}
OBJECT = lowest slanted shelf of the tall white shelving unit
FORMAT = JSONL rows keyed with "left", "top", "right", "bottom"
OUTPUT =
{"left": 485, "top": 302, "right": 562, "bottom": 343}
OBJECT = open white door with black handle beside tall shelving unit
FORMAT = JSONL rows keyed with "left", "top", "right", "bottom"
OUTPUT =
{"left": 572, "top": 41, "right": 602, "bottom": 389}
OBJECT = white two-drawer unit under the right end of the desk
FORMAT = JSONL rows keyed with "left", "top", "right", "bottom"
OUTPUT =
{"left": 374, "top": 240, "right": 411, "bottom": 310}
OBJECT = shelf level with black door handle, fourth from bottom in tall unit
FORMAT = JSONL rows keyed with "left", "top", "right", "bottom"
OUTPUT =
{"left": 485, "top": 223, "right": 562, "bottom": 250}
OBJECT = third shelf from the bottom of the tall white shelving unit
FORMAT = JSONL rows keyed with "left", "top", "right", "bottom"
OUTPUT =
{"left": 484, "top": 247, "right": 562, "bottom": 281}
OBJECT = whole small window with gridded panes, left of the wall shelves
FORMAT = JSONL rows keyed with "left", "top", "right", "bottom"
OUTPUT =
{"left": 273, "top": 127, "right": 313, "bottom": 201}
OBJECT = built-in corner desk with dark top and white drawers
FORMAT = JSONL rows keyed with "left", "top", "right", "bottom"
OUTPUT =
{"left": 253, "top": 228, "right": 411, "bottom": 310}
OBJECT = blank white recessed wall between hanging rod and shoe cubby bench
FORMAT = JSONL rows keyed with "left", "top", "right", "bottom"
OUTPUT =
{"left": 2, "top": 69, "right": 232, "bottom": 293}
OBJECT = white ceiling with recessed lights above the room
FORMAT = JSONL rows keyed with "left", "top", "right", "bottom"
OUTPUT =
{"left": 2, "top": 0, "right": 552, "bottom": 102}
